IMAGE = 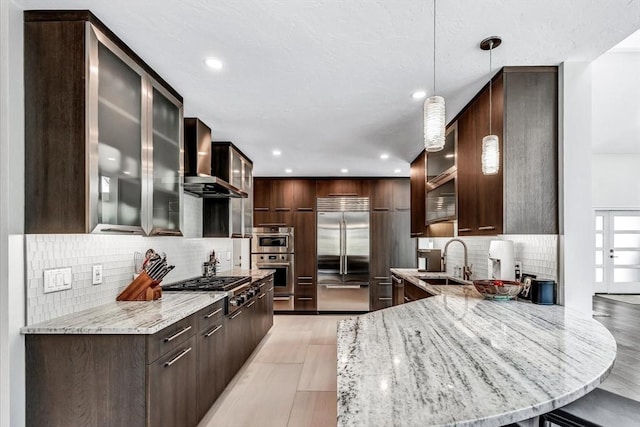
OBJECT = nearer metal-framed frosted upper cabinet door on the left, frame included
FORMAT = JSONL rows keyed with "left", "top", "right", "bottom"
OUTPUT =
{"left": 87, "top": 25, "right": 147, "bottom": 233}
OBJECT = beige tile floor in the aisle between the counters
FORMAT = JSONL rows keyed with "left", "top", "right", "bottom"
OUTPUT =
{"left": 198, "top": 315, "right": 348, "bottom": 427}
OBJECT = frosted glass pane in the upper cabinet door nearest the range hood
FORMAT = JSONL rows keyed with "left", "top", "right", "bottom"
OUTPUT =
{"left": 151, "top": 88, "right": 182, "bottom": 234}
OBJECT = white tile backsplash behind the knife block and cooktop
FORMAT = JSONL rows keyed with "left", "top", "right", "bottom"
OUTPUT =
{"left": 25, "top": 234, "right": 233, "bottom": 324}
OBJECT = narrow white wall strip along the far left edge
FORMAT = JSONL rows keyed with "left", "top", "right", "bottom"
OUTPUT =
{"left": 0, "top": 0, "right": 25, "bottom": 427}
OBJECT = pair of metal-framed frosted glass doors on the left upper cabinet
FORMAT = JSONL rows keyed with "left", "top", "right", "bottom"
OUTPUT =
{"left": 87, "top": 24, "right": 182, "bottom": 235}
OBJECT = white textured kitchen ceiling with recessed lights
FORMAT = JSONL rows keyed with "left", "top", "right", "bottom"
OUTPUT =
{"left": 17, "top": 0, "right": 640, "bottom": 176}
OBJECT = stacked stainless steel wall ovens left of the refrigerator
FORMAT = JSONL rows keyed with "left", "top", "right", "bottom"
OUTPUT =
{"left": 251, "top": 227, "right": 295, "bottom": 311}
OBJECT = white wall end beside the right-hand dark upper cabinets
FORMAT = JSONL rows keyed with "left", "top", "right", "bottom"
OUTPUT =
{"left": 558, "top": 62, "right": 595, "bottom": 316}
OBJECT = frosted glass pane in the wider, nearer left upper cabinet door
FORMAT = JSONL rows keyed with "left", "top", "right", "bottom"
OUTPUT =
{"left": 97, "top": 43, "right": 142, "bottom": 227}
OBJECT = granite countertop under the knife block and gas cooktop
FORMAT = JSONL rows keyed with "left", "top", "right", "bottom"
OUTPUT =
{"left": 20, "top": 292, "right": 227, "bottom": 335}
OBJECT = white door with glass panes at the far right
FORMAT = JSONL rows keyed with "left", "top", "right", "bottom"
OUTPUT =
{"left": 595, "top": 211, "right": 640, "bottom": 294}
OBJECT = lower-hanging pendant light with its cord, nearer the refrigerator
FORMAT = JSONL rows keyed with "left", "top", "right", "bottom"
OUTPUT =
{"left": 424, "top": 0, "right": 445, "bottom": 152}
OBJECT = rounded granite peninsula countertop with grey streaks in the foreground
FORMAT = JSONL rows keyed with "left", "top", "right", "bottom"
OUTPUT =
{"left": 338, "top": 285, "right": 616, "bottom": 426}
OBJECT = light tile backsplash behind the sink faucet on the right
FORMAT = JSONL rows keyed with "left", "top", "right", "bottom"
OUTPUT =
{"left": 419, "top": 234, "right": 558, "bottom": 282}
